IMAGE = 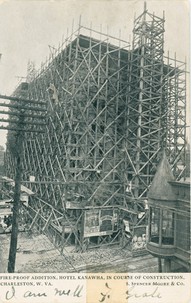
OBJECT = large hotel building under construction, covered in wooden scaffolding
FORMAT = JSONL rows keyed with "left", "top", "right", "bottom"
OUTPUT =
{"left": 6, "top": 8, "right": 186, "bottom": 254}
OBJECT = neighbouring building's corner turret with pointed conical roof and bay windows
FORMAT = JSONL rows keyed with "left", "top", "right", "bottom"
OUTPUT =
{"left": 147, "top": 153, "right": 191, "bottom": 272}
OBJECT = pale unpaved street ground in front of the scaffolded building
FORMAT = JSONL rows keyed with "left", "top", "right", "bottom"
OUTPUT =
{"left": 0, "top": 233, "right": 158, "bottom": 273}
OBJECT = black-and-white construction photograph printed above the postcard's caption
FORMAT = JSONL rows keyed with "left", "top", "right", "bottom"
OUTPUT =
{"left": 0, "top": 0, "right": 191, "bottom": 280}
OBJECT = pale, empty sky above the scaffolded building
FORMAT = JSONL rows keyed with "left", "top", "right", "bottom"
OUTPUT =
{"left": 0, "top": 0, "right": 190, "bottom": 146}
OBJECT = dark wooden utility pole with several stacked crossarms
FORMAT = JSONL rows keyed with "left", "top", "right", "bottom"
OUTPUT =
{"left": 0, "top": 86, "right": 46, "bottom": 273}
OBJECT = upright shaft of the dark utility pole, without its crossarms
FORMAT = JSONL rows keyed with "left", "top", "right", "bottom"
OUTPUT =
{"left": 8, "top": 113, "right": 24, "bottom": 273}
